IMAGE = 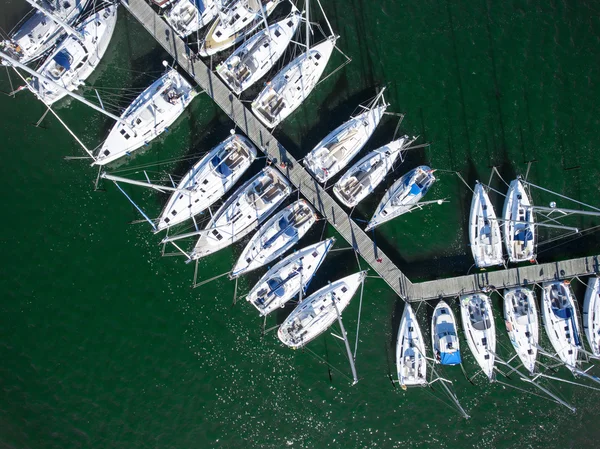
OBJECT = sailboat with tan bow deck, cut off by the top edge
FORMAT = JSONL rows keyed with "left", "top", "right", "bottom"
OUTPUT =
{"left": 199, "top": 0, "right": 281, "bottom": 56}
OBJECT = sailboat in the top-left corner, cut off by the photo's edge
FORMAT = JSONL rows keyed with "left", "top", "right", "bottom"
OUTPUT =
{"left": 0, "top": 0, "right": 90, "bottom": 64}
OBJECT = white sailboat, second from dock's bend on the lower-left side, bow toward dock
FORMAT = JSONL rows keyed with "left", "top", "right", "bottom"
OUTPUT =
{"left": 246, "top": 237, "right": 335, "bottom": 316}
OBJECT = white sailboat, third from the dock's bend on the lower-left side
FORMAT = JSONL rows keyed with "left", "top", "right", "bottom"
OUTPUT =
{"left": 230, "top": 200, "right": 317, "bottom": 278}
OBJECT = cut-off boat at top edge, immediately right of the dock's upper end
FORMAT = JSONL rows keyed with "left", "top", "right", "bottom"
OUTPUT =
{"left": 164, "top": 0, "right": 221, "bottom": 39}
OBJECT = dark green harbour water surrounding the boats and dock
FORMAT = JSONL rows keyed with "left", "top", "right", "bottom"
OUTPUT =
{"left": 0, "top": 0, "right": 600, "bottom": 449}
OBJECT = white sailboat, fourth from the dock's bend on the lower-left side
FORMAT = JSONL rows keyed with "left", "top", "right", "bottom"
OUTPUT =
{"left": 190, "top": 166, "right": 292, "bottom": 259}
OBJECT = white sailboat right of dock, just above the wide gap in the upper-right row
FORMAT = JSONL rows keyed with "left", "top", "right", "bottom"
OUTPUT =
{"left": 252, "top": 36, "right": 337, "bottom": 128}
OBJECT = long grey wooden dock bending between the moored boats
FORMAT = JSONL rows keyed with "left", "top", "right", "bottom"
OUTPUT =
{"left": 121, "top": 0, "right": 598, "bottom": 301}
